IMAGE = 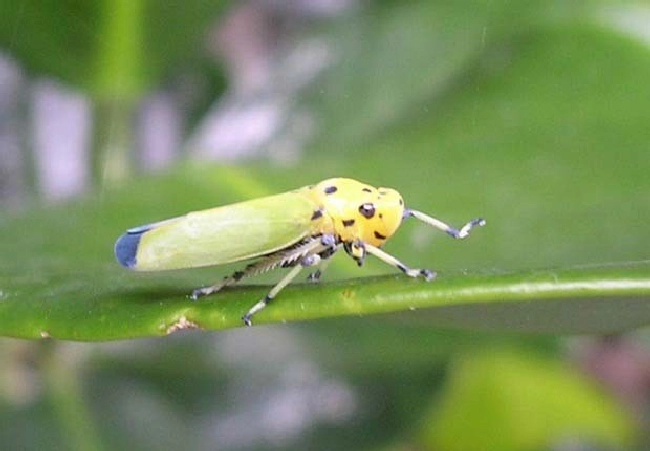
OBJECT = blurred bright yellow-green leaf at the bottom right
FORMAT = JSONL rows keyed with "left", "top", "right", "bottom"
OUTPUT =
{"left": 423, "top": 348, "right": 634, "bottom": 451}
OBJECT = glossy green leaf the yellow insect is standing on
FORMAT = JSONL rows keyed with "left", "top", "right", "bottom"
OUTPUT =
{"left": 0, "top": 168, "right": 650, "bottom": 340}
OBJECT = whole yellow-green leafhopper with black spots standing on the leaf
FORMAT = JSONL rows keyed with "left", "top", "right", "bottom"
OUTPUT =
{"left": 115, "top": 178, "right": 485, "bottom": 326}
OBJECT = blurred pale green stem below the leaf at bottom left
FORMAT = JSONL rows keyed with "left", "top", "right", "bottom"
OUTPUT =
{"left": 41, "top": 341, "right": 102, "bottom": 451}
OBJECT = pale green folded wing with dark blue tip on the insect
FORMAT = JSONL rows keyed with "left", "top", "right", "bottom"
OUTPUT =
{"left": 115, "top": 192, "right": 315, "bottom": 271}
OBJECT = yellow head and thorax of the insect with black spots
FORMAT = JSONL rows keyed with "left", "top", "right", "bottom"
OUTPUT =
{"left": 302, "top": 178, "right": 404, "bottom": 246}
